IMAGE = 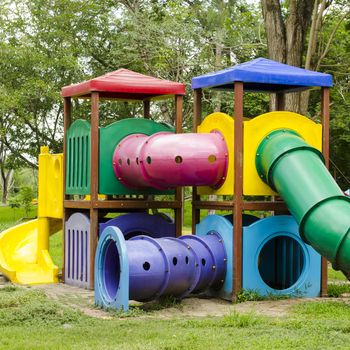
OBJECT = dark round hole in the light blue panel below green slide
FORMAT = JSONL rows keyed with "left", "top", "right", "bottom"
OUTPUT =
{"left": 258, "top": 235, "right": 305, "bottom": 290}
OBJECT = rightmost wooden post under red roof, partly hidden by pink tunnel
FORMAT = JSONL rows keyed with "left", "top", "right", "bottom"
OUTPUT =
{"left": 175, "top": 95, "right": 183, "bottom": 237}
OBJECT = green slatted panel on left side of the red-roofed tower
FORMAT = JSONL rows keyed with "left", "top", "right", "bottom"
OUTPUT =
{"left": 66, "top": 119, "right": 91, "bottom": 195}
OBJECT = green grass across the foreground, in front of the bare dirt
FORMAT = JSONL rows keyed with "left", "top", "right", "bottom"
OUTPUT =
{"left": 0, "top": 288, "right": 350, "bottom": 350}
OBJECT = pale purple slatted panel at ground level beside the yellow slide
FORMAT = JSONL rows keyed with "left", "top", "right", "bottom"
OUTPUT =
{"left": 64, "top": 213, "right": 90, "bottom": 288}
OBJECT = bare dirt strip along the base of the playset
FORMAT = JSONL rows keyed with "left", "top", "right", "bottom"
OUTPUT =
{"left": 0, "top": 275, "right": 350, "bottom": 319}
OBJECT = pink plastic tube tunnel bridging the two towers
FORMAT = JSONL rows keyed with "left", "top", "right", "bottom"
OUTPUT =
{"left": 113, "top": 132, "right": 228, "bottom": 190}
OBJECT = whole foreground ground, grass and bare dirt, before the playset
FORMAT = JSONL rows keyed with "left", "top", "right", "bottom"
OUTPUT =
{"left": 0, "top": 279, "right": 350, "bottom": 350}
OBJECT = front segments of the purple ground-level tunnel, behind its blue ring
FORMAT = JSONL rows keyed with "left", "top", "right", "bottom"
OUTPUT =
{"left": 126, "top": 236, "right": 200, "bottom": 301}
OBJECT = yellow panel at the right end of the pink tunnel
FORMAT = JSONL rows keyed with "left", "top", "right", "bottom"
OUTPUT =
{"left": 197, "top": 112, "right": 234, "bottom": 195}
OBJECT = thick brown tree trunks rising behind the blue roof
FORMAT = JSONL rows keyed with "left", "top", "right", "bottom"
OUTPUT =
{"left": 261, "top": 0, "right": 349, "bottom": 114}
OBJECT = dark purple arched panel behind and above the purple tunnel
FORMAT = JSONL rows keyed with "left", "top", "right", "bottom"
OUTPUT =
{"left": 99, "top": 213, "right": 176, "bottom": 239}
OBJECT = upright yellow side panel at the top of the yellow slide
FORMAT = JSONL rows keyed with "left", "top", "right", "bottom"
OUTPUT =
{"left": 38, "top": 147, "right": 63, "bottom": 219}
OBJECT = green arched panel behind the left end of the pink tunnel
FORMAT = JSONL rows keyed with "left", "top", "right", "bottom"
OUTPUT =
{"left": 99, "top": 118, "right": 174, "bottom": 195}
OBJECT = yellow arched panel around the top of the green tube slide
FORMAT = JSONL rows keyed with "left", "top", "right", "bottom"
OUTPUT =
{"left": 243, "top": 111, "right": 322, "bottom": 196}
